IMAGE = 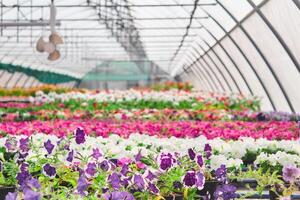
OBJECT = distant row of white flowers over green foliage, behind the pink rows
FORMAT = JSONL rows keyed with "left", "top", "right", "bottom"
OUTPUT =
{"left": 30, "top": 90, "right": 259, "bottom": 110}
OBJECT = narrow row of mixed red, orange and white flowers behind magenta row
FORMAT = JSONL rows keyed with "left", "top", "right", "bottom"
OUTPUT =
{"left": 0, "top": 107, "right": 300, "bottom": 122}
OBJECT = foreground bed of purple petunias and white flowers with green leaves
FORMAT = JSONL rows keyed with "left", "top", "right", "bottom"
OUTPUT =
{"left": 0, "top": 128, "right": 300, "bottom": 200}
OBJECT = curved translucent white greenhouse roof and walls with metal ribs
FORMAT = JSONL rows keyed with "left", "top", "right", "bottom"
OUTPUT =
{"left": 0, "top": 0, "right": 300, "bottom": 112}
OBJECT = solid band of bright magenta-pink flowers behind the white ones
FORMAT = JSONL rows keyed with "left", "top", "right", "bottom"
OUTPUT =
{"left": 0, "top": 120, "right": 300, "bottom": 140}
